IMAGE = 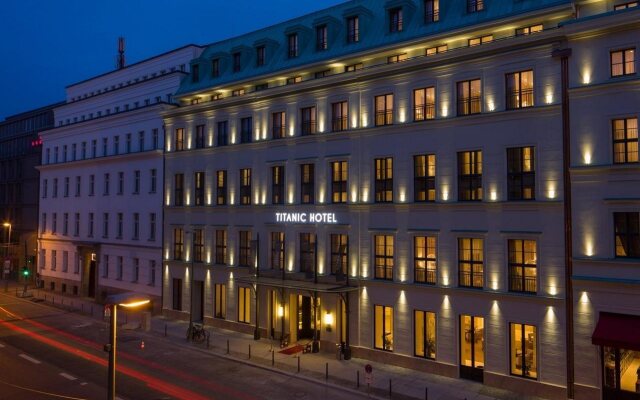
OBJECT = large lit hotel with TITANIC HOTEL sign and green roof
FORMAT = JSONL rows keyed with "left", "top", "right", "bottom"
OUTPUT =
{"left": 162, "top": 0, "right": 640, "bottom": 399}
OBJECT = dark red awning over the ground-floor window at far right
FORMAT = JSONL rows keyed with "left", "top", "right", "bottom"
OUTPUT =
{"left": 591, "top": 313, "right": 640, "bottom": 351}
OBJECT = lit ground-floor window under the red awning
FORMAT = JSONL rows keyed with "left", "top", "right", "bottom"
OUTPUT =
{"left": 602, "top": 346, "right": 640, "bottom": 400}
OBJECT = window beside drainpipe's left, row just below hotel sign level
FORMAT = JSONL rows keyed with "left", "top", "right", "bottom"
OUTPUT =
{"left": 508, "top": 239, "right": 537, "bottom": 293}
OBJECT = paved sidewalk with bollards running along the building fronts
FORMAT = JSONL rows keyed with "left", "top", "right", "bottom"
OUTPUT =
{"left": 22, "top": 287, "right": 542, "bottom": 400}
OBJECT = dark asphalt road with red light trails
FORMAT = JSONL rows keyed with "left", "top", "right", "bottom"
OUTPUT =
{"left": 0, "top": 293, "right": 362, "bottom": 400}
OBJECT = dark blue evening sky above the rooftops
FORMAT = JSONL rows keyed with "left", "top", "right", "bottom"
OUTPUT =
{"left": 0, "top": 0, "right": 345, "bottom": 120}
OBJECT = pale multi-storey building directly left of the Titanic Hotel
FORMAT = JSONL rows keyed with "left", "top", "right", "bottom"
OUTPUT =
{"left": 38, "top": 45, "right": 201, "bottom": 306}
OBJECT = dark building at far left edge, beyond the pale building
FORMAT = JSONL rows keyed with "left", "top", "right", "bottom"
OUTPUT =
{"left": 0, "top": 104, "right": 59, "bottom": 278}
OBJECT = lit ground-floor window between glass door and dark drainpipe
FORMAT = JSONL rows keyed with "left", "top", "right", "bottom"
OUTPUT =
{"left": 510, "top": 323, "right": 538, "bottom": 379}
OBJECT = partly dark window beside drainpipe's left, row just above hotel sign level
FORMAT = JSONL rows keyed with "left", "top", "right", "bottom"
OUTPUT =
{"left": 507, "top": 146, "right": 536, "bottom": 200}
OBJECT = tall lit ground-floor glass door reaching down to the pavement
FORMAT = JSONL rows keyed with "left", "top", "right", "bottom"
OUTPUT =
{"left": 460, "top": 315, "right": 485, "bottom": 382}
